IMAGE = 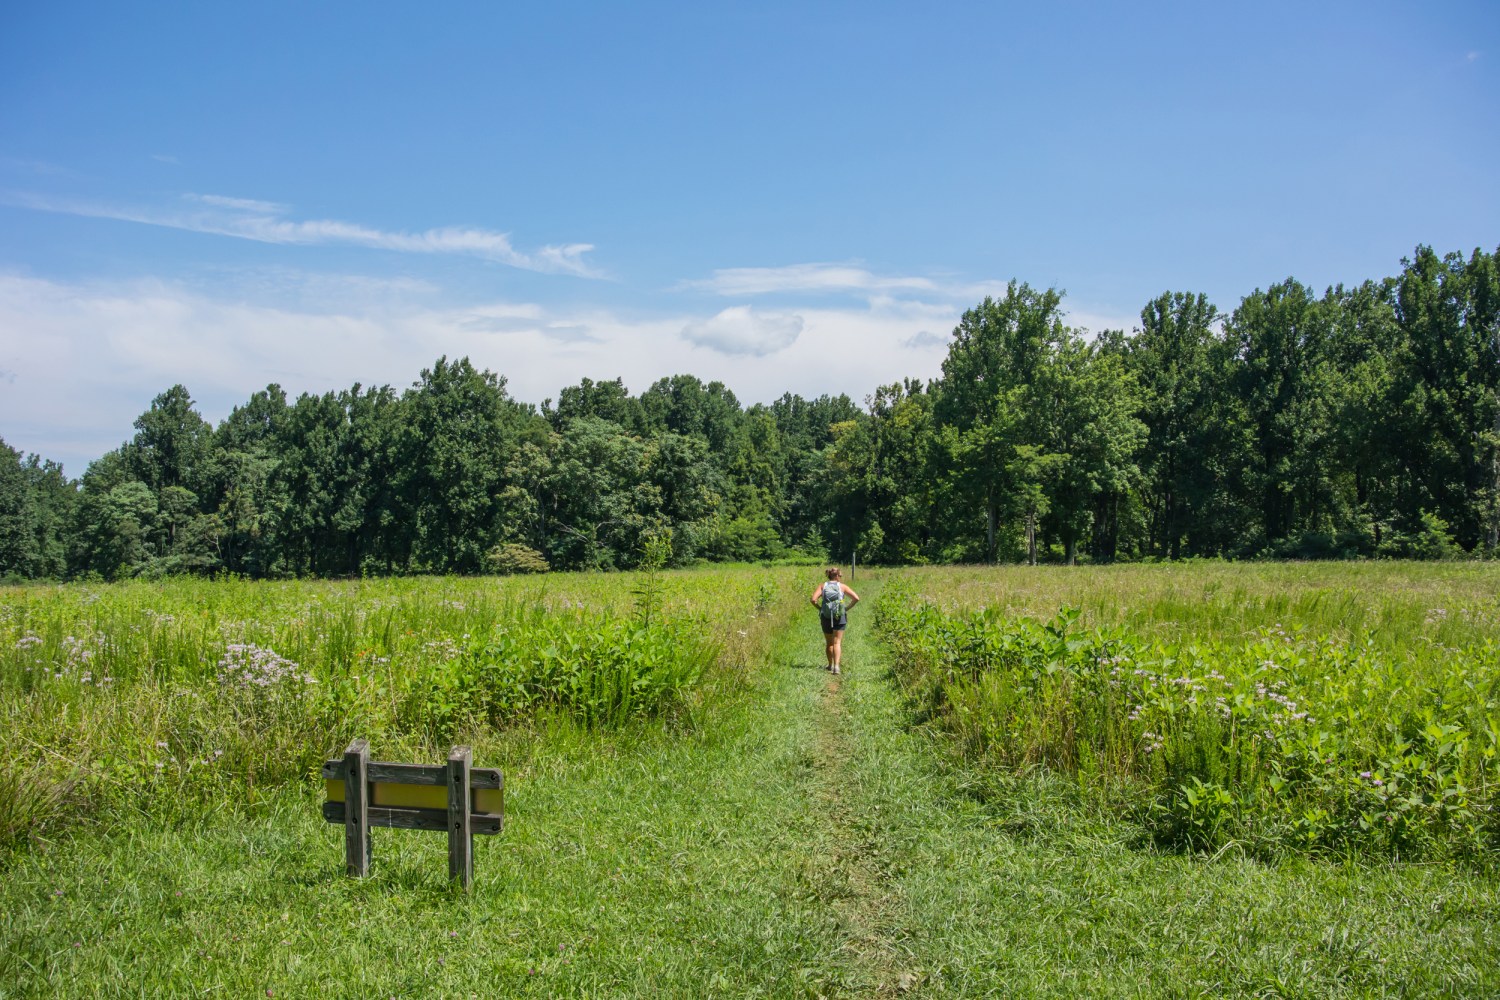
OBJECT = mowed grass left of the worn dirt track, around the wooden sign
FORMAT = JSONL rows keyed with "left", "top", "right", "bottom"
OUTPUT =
{"left": 0, "top": 590, "right": 858, "bottom": 997}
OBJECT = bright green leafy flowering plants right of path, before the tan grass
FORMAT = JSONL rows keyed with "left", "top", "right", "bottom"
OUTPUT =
{"left": 876, "top": 575, "right": 1500, "bottom": 861}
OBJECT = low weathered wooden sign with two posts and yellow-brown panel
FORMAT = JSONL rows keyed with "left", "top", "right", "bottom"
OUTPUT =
{"left": 323, "top": 739, "right": 506, "bottom": 889}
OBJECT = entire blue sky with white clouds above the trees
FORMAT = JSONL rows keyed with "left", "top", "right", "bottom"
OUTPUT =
{"left": 0, "top": 1, "right": 1500, "bottom": 475}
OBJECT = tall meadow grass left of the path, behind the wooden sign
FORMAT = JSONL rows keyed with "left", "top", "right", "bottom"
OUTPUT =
{"left": 0, "top": 568, "right": 791, "bottom": 850}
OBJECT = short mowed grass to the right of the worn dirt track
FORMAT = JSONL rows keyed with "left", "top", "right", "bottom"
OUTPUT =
{"left": 825, "top": 586, "right": 1500, "bottom": 997}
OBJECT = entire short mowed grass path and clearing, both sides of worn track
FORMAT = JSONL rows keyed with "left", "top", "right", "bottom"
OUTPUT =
{"left": 0, "top": 574, "right": 1500, "bottom": 997}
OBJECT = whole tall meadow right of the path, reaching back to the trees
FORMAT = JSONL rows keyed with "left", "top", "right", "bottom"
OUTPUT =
{"left": 878, "top": 567, "right": 1500, "bottom": 861}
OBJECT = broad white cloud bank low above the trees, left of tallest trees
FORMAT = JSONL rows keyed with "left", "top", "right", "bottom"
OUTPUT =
{"left": 0, "top": 274, "right": 960, "bottom": 475}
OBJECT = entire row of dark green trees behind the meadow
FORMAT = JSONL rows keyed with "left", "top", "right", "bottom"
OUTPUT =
{"left": 0, "top": 246, "right": 1500, "bottom": 579}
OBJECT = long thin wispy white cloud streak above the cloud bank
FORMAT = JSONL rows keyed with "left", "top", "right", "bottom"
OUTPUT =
{"left": 0, "top": 192, "right": 600, "bottom": 277}
